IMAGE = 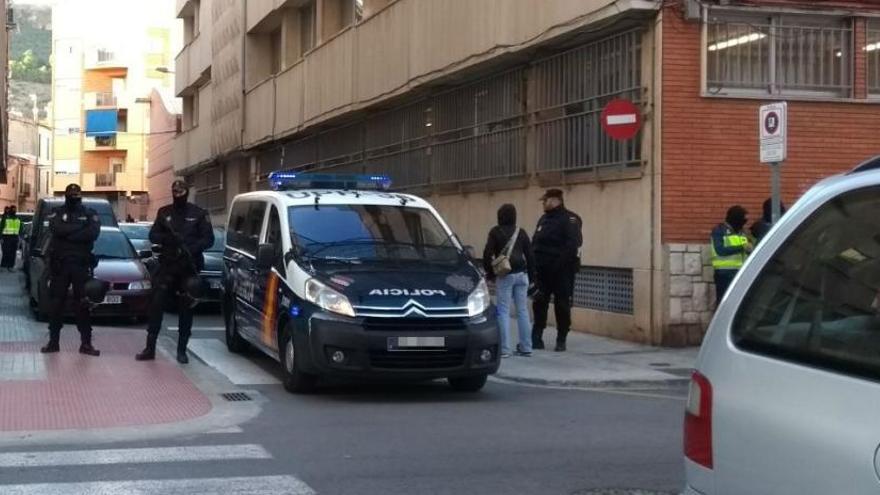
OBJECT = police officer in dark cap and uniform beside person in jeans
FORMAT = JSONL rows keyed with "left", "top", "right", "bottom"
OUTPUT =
{"left": 532, "top": 189, "right": 583, "bottom": 352}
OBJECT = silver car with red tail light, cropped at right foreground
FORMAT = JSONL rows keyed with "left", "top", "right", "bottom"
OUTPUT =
{"left": 684, "top": 156, "right": 880, "bottom": 495}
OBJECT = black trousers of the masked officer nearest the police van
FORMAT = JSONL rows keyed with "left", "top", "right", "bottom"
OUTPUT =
{"left": 147, "top": 264, "right": 195, "bottom": 347}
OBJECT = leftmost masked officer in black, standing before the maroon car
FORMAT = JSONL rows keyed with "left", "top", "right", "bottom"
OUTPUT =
{"left": 40, "top": 184, "right": 101, "bottom": 356}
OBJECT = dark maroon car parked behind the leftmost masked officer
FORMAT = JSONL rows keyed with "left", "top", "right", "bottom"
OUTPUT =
{"left": 29, "top": 227, "right": 152, "bottom": 321}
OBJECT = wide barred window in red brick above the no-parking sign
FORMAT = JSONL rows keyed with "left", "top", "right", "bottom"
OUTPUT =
{"left": 705, "top": 13, "right": 853, "bottom": 97}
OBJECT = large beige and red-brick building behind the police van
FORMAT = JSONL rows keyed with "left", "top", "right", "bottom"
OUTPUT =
{"left": 174, "top": 0, "right": 880, "bottom": 345}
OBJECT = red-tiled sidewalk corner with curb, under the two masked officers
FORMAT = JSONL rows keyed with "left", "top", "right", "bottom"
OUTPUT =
{"left": 0, "top": 330, "right": 212, "bottom": 433}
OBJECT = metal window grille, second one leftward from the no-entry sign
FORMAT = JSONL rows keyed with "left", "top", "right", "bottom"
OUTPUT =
{"left": 431, "top": 68, "right": 526, "bottom": 184}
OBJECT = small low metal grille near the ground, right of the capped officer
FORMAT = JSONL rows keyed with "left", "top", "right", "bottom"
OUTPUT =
{"left": 574, "top": 266, "right": 633, "bottom": 315}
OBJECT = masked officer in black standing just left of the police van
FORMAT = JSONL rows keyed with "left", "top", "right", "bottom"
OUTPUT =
{"left": 135, "top": 180, "right": 214, "bottom": 364}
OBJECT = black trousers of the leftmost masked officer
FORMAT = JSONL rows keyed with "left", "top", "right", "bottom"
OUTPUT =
{"left": 49, "top": 258, "right": 92, "bottom": 345}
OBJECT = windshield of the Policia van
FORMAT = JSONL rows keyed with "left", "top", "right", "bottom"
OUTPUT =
{"left": 288, "top": 205, "right": 460, "bottom": 262}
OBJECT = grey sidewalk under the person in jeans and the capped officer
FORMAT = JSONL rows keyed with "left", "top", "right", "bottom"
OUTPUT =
{"left": 495, "top": 323, "right": 699, "bottom": 388}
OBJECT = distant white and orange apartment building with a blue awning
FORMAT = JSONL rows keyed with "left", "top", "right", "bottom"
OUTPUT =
{"left": 51, "top": 0, "right": 177, "bottom": 218}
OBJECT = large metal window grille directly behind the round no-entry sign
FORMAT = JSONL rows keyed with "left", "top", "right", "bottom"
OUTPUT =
{"left": 533, "top": 30, "right": 642, "bottom": 172}
